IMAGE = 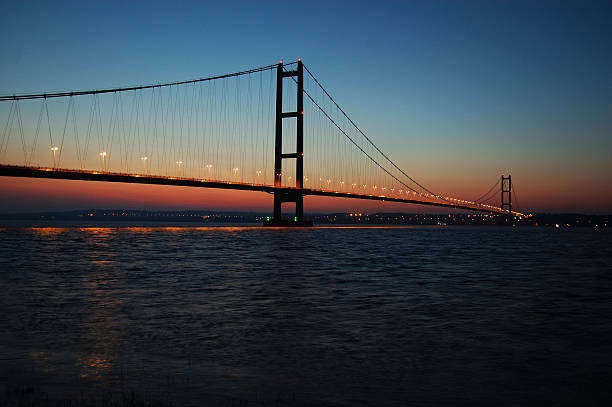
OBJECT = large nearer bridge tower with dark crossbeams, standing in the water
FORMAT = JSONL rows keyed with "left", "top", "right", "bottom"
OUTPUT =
{"left": 264, "top": 59, "right": 312, "bottom": 226}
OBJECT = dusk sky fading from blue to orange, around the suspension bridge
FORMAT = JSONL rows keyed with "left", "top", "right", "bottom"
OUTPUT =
{"left": 0, "top": 1, "right": 612, "bottom": 213}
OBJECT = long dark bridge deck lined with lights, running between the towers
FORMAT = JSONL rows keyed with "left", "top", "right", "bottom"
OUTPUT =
{"left": 0, "top": 165, "right": 521, "bottom": 216}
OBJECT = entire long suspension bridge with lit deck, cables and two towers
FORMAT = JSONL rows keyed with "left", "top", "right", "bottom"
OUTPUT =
{"left": 0, "top": 60, "right": 524, "bottom": 226}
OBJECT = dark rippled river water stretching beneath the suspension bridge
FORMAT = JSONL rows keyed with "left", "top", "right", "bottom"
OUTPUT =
{"left": 0, "top": 226, "right": 612, "bottom": 406}
